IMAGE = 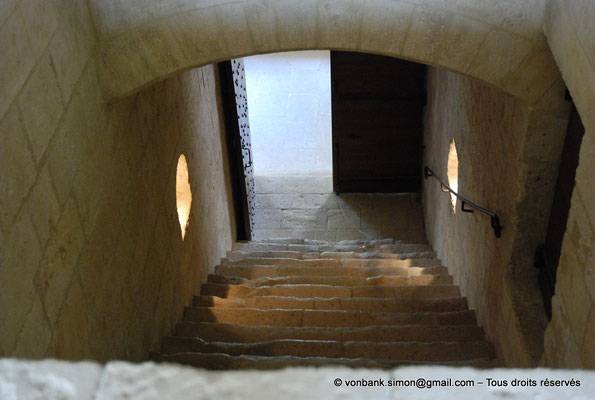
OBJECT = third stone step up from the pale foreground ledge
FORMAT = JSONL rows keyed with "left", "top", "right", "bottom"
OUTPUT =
{"left": 171, "top": 321, "right": 484, "bottom": 342}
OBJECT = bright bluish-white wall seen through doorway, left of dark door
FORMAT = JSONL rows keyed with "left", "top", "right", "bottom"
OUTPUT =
{"left": 244, "top": 51, "right": 333, "bottom": 176}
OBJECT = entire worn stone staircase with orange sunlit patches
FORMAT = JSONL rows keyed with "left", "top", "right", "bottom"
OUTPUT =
{"left": 154, "top": 239, "right": 497, "bottom": 369}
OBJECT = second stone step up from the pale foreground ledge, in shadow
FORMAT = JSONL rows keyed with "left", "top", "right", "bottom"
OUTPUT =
{"left": 162, "top": 337, "right": 493, "bottom": 361}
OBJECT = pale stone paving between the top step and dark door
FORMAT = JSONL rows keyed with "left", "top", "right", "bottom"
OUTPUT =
{"left": 253, "top": 176, "right": 426, "bottom": 243}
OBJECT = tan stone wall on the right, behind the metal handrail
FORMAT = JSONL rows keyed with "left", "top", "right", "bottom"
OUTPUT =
{"left": 423, "top": 68, "right": 545, "bottom": 366}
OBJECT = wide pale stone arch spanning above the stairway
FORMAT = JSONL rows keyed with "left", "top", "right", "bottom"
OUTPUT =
{"left": 92, "top": 0, "right": 559, "bottom": 104}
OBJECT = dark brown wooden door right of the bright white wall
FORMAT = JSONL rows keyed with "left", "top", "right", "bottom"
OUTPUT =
{"left": 331, "top": 51, "right": 426, "bottom": 193}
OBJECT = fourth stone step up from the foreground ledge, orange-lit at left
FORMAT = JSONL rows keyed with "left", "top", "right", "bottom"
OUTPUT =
{"left": 184, "top": 307, "right": 476, "bottom": 327}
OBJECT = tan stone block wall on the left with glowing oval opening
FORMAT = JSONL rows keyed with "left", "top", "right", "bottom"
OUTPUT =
{"left": 0, "top": 0, "right": 235, "bottom": 360}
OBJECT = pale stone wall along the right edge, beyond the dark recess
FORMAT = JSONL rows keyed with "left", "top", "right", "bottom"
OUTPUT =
{"left": 542, "top": 0, "right": 595, "bottom": 368}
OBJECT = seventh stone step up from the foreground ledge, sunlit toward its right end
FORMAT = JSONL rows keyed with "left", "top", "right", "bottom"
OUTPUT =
{"left": 207, "top": 274, "right": 453, "bottom": 287}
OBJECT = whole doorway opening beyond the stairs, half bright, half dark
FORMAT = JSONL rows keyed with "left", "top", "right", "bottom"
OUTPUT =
{"left": 225, "top": 51, "right": 425, "bottom": 241}
